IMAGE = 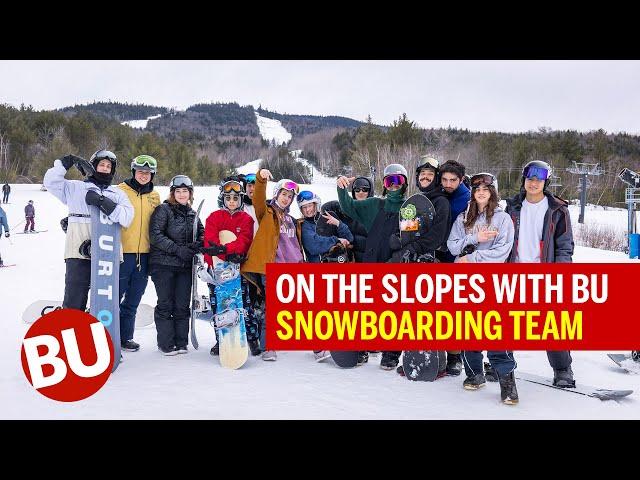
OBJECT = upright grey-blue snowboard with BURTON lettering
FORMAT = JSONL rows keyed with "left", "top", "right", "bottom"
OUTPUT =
{"left": 89, "top": 205, "right": 121, "bottom": 372}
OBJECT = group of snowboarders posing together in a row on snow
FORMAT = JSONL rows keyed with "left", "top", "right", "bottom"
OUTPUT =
{"left": 38, "top": 150, "right": 574, "bottom": 403}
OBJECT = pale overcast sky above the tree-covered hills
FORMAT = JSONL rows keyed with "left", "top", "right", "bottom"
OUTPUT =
{"left": 0, "top": 60, "right": 640, "bottom": 134}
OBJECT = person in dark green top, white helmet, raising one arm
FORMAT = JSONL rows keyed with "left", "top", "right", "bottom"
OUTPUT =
{"left": 336, "top": 163, "right": 407, "bottom": 370}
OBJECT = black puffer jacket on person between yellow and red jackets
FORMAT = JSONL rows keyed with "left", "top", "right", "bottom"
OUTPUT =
{"left": 149, "top": 200, "right": 204, "bottom": 269}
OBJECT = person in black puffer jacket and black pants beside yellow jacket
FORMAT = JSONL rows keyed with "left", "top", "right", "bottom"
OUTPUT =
{"left": 149, "top": 175, "right": 204, "bottom": 356}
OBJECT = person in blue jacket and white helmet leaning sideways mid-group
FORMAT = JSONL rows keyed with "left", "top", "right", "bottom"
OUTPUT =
{"left": 296, "top": 190, "right": 353, "bottom": 362}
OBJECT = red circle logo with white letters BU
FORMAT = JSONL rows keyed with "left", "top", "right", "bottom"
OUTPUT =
{"left": 21, "top": 308, "right": 114, "bottom": 402}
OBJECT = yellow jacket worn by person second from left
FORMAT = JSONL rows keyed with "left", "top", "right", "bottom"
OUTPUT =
{"left": 118, "top": 182, "right": 160, "bottom": 253}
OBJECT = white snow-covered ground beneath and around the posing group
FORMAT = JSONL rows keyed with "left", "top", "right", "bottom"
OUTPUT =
{"left": 0, "top": 177, "right": 640, "bottom": 419}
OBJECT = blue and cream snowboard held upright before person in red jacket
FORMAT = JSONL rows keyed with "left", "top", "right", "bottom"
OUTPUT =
{"left": 213, "top": 230, "right": 249, "bottom": 369}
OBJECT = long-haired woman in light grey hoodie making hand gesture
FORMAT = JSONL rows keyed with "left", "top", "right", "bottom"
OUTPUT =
{"left": 447, "top": 173, "right": 518, "bottom": 405}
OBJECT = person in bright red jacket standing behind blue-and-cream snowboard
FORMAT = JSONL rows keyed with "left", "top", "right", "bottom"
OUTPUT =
{"left": 204, "top": 175, "right": 262, "bottom": 355}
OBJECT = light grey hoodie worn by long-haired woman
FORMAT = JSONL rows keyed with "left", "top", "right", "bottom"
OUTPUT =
{"left": 447, "top": 207, "right": 514, "bottom": 263}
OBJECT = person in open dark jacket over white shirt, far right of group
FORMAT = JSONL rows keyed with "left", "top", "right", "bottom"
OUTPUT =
{"left": 506, "top": 160, "right": 575, "bottom": 387}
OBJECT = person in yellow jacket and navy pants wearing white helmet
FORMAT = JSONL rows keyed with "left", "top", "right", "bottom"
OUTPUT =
{"left": 118, "top": 155, "right": 160, "bottom": 352}
